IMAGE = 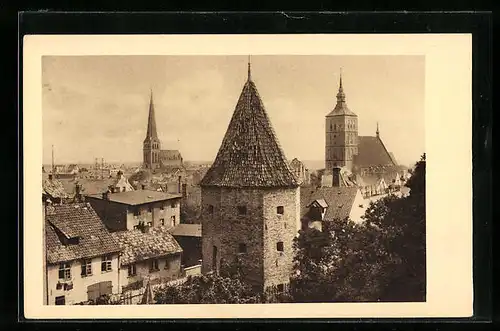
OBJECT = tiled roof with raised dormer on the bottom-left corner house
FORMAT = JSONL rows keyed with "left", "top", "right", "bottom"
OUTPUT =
{"left": 45, "top": 203, "right": 120, "bottom": 264}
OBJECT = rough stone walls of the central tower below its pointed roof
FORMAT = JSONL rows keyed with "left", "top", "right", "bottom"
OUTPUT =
{"left": 202, "top": 188, "right": 300, "bottom": 292}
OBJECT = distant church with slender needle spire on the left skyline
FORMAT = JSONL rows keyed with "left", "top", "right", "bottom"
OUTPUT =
{"left": 142, "top": 92, "right": 183, "bottom": 170}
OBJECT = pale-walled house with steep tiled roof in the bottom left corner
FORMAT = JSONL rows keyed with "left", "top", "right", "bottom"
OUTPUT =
{"left": 45, "top": 203, "right": 120, "bottom": 305}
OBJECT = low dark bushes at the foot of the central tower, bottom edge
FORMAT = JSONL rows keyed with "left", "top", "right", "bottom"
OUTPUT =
{"left": 155, "top": 264, "right": 262, "bottom": 304}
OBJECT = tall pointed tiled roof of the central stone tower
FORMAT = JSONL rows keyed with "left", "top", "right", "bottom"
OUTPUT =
{"left": 200, "top": 63, "right": 298, "bottom": 188}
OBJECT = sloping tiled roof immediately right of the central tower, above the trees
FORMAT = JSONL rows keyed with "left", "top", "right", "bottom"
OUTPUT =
{"left": 300, "top": 187, "right": 358, "bottom": 221}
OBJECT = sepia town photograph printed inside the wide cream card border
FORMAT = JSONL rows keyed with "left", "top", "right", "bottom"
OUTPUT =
{"left": 22, "top": 34, "right": 472, "bottom": 320}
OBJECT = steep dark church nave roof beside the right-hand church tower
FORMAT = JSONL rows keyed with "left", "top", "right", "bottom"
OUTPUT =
{"left": 353, "top": 136, "right": 395, "bottom": 167}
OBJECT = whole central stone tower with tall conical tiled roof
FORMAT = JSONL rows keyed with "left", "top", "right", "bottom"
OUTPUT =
{"left": 200, "top": 59, "right": 300, "bottom": 291}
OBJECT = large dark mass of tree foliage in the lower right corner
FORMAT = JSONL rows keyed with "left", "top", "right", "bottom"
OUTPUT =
{"left": 291, "top": 154, "right": 426, "bottom": 302}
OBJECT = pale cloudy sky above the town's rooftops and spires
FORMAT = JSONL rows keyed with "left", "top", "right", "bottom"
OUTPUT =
{"left": 42, "top": 55, "right": 425, "bottom": 165}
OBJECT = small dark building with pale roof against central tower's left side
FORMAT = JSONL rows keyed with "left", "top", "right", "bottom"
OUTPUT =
{"left": 170, "top": 223, "right": 202, "bottom": 267}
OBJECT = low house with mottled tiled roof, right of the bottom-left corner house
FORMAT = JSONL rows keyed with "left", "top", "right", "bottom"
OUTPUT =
{"left": 111, "top": 226, "right": 182, "bottom": 293}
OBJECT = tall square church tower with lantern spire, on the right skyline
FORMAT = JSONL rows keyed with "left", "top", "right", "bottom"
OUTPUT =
{"left": 325, "top": 73, "right": 358, "bottom": 171}
